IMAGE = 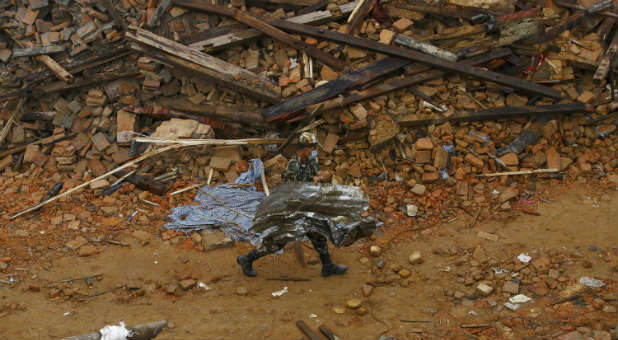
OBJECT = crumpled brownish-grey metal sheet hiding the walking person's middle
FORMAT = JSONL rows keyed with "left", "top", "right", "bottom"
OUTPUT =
{"left": 249, "top": 182, "right": 376, "bottom": 251}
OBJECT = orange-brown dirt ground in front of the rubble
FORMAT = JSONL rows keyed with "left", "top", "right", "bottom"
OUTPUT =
{"left": 0, "top": 179, "right": 618, "bottom": 339}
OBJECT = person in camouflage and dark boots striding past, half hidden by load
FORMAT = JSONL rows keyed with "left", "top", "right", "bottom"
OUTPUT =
{"left": 236, "top": 133, "right": 348, "bottom": 277}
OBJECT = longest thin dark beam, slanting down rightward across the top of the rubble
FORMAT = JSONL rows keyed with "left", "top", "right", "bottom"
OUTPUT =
{"left": 174, "top": 0, "right": 562, "bottom": 99}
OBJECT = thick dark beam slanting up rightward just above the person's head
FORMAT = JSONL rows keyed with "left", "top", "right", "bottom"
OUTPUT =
{"left": 262, "top": 57, "right": 411, "bottom": 122}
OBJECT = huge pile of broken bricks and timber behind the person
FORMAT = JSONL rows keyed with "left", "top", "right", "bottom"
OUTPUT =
{"left": 0, "top": 0, "right": 618, "bottom": 338}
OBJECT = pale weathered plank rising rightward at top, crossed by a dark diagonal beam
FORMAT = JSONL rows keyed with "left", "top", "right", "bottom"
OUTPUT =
{"left": 189, "top": 2, "right": 356, "bottom": 50}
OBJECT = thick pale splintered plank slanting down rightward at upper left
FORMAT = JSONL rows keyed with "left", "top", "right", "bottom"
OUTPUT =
{"left": 126, "top": 28, "right": 279, "bottom": 103}
